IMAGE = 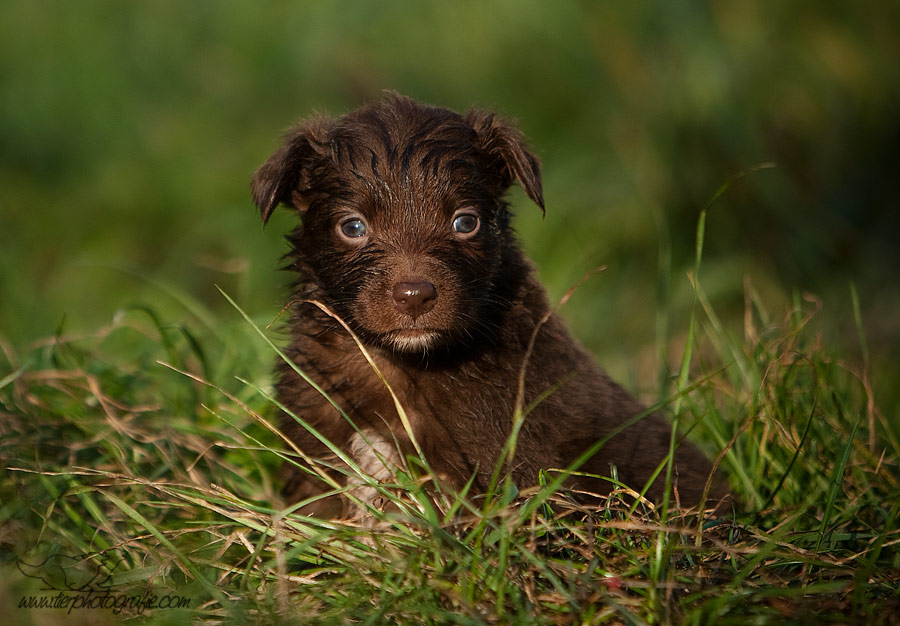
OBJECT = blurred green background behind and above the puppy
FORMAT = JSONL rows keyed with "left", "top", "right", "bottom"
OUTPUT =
{"left": 0, "top": 0, "right": 900, "bottom": 404}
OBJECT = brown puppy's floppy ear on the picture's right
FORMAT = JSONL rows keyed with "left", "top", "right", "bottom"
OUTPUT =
{"left": 466, "top": 109, "right": 544, "bottom": 211}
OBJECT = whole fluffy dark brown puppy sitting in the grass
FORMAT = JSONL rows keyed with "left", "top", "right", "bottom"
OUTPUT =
{"left": 252, "top": 95, "right": 710, "bottom": 516}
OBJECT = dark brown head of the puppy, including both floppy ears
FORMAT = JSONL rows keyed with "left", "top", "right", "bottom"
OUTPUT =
{"left": 252, "top": 95, "right": 543, "bottom": 354}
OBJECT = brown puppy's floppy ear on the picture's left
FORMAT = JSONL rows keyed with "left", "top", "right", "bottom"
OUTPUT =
{"left": 250, "top": 118, "right": 332, "bottom": 224}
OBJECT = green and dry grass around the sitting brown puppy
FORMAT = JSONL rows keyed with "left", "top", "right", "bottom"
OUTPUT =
{"left": 0, "top": 234, "right": 900, "bottom": 624}
